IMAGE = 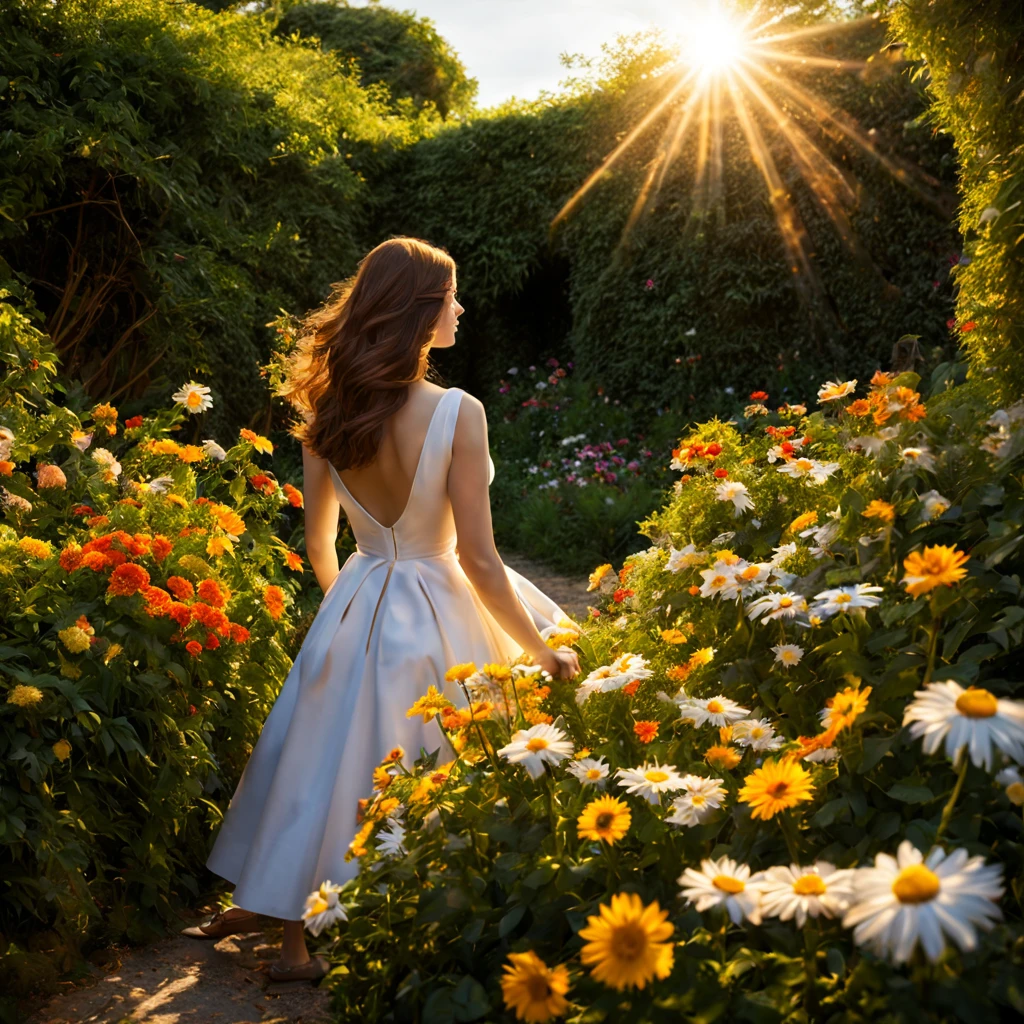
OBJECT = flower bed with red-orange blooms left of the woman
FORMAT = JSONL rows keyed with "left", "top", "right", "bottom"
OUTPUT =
{"left": 0, "top": 292, "right": 309, "bottom": 970}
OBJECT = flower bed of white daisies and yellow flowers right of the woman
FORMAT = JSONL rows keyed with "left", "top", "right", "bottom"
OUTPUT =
{"left": 307, "top": 370, "right": 1024, "bottom": 1022}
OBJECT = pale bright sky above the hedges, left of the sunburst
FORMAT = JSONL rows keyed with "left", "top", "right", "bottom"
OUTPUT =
{"left": 352, "top": 0, "right": 693, "bottom": 106}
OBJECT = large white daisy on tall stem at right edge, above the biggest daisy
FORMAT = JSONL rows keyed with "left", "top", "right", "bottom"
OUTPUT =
{"left": 903, "top": 679, "right": 1024, "bottom": 771}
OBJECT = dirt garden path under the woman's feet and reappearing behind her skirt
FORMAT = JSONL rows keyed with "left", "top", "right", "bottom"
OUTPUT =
{"left": 27, "top": 554, "right": 588, "bottom": 1024}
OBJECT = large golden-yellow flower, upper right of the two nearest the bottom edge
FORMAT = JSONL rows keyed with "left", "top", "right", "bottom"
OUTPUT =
{"left": 580, "top": 893, "right": 675, "bottom": 991}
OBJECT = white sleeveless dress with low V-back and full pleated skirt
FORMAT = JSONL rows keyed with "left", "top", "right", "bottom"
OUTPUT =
{"left": 207, "top": 388, "right": 567, "bottom": 921}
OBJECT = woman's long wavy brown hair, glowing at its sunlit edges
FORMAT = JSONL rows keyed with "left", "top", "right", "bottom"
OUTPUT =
{"left": 279, "top": 238, "right": 455, "bottom": 470}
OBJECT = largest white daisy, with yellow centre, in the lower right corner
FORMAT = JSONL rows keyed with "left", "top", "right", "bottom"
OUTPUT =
{"left": 843, "top": 840, "right": 1002, "bottom": 964}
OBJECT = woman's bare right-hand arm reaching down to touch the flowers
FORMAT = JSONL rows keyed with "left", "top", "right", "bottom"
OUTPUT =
{"left": 447, "top": 394, "right": 580, "bottom": 675}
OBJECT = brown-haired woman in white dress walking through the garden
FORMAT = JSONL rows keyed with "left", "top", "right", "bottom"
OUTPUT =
{"left": 186, "top": 238, "right": 580, "bottom": 980}
